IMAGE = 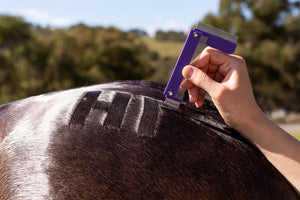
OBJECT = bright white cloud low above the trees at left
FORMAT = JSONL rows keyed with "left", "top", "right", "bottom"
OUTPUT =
{"left": 20, "top": 9, "right": 72, "bottom": 27}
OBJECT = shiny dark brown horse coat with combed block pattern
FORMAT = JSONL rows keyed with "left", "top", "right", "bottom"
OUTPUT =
{"left": 0, "top": 81, "right": 299, "bottom": 200}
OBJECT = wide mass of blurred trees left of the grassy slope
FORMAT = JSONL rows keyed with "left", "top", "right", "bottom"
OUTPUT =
{"left": 0, "top": 15, "right": 154, "bottom": 104}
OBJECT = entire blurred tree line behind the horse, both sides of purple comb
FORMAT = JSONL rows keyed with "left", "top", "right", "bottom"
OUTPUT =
{"left": 0, "top": 0, "right": 300, "bottom": 111}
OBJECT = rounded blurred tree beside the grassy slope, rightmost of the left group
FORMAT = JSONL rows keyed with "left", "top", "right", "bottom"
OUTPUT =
{"left": 96, "top": 27, "right": 153, "bottom": 80}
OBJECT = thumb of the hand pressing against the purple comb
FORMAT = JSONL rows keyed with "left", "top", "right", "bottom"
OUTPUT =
{"left": 182, "top": 65, "right": 219, "bottom": 96}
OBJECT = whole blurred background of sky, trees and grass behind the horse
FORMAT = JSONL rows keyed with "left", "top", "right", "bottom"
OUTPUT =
{"left": 0, "top": 0, "right": 300, "bottom": 133}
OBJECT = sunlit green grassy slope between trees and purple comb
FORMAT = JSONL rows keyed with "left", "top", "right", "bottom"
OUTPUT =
{"left": 141, "top": 37, "right": 184, "bottom": 58}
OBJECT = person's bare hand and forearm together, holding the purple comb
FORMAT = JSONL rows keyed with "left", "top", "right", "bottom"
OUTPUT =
{"left": 182, "top": 47, "right": 300, "bottom": 193}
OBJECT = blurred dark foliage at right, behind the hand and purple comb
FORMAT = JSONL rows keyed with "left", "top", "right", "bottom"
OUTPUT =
{"left": 203, "top": 0, "right": 300, "bottom": 111}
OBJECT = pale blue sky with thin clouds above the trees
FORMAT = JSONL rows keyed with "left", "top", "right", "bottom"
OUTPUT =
{"left": 0, "top": 0, "right": 220, "bottom": 35}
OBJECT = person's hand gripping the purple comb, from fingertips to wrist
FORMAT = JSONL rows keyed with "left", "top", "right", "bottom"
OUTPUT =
{"left": 182, "top": 47, "right": 261, "bottom": 130}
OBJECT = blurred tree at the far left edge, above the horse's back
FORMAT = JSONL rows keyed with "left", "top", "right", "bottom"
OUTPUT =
{"left": 0, "top": 15, "right": 32, "bottom": 103}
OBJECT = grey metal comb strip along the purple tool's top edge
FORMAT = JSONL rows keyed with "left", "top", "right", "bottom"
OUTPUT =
{"left": 197, "top": 23, "right": 239, "bottom": 43}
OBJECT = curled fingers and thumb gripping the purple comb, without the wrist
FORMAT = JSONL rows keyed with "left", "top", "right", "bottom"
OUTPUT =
{"left": 181, "top": 47, "right": 246, "bottom": 107}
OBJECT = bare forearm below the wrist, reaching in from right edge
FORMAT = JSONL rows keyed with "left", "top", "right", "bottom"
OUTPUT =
{"left": 238, "top": 108, "right": 300, "bottom": 192}
